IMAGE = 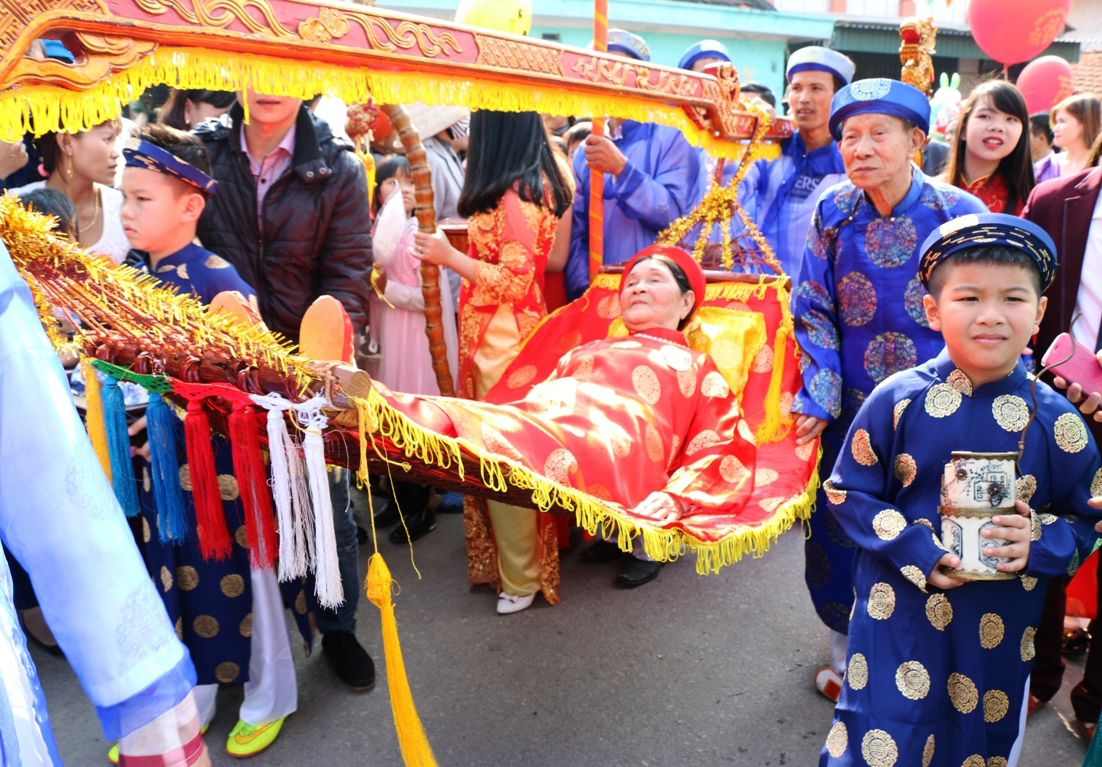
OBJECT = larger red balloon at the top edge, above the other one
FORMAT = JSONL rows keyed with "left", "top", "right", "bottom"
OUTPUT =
{"left": 968, "top": 0, "right": 1071, "bottom": 64}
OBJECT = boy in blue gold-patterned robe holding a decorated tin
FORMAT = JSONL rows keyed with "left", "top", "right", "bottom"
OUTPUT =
{"left": 820, "top": 214, "right": 1102, "bottom": 767}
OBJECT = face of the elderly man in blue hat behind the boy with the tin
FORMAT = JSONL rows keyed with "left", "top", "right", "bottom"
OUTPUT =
{"left": 838, "top": 115, "right": 926, "bottom": 195}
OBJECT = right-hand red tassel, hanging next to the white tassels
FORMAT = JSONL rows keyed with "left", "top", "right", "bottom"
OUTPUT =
{"left": 229, "top": 401, "right": 279, "bottom": 570}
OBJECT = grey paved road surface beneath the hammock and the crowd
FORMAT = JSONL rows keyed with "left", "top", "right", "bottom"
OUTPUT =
{"left": 35, "top": 500, "right": 1085, "bottom": 767}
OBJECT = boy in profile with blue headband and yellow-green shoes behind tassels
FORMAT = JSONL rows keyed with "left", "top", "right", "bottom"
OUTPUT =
{"left": 115, "top": 125, "right": 311, "bottom": 761}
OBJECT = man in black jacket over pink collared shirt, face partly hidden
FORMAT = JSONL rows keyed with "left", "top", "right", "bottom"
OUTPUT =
{"left": 195, "top": 91, "right": 375, "bottom": 690}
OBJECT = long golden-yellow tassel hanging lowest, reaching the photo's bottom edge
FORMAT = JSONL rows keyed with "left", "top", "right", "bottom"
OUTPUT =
{"left": 365, "top": 552, "right": 436, "bottom": 767}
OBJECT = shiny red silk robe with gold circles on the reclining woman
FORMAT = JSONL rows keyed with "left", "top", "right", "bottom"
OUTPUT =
{"left": 375, "top": 328, "right": 756, "bottom": 557}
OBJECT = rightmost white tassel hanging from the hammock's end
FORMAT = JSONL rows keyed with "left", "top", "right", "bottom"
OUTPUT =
{"left": 298, "top": 397, "right": 344, "bottom": 607}
